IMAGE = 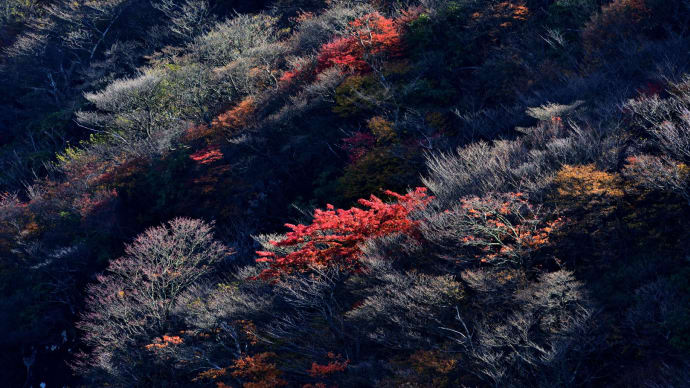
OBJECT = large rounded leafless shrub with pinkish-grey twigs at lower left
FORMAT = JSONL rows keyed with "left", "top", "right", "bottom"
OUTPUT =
{"left": 77, "top": 218, "right": 229, "bottom": 386}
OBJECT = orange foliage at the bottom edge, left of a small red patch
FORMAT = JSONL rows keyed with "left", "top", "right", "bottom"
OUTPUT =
{"left": 232, "top": 352, "right": 287, "bottom": 388}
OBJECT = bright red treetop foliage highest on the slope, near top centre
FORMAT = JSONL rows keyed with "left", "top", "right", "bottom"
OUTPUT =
{"left": 316, "top": 12, "right": 401, "bottom": 73}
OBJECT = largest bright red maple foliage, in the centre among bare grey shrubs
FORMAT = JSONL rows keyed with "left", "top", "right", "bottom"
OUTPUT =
{"left": 257, "top": 187, "right": 433, "bottom": 280}
